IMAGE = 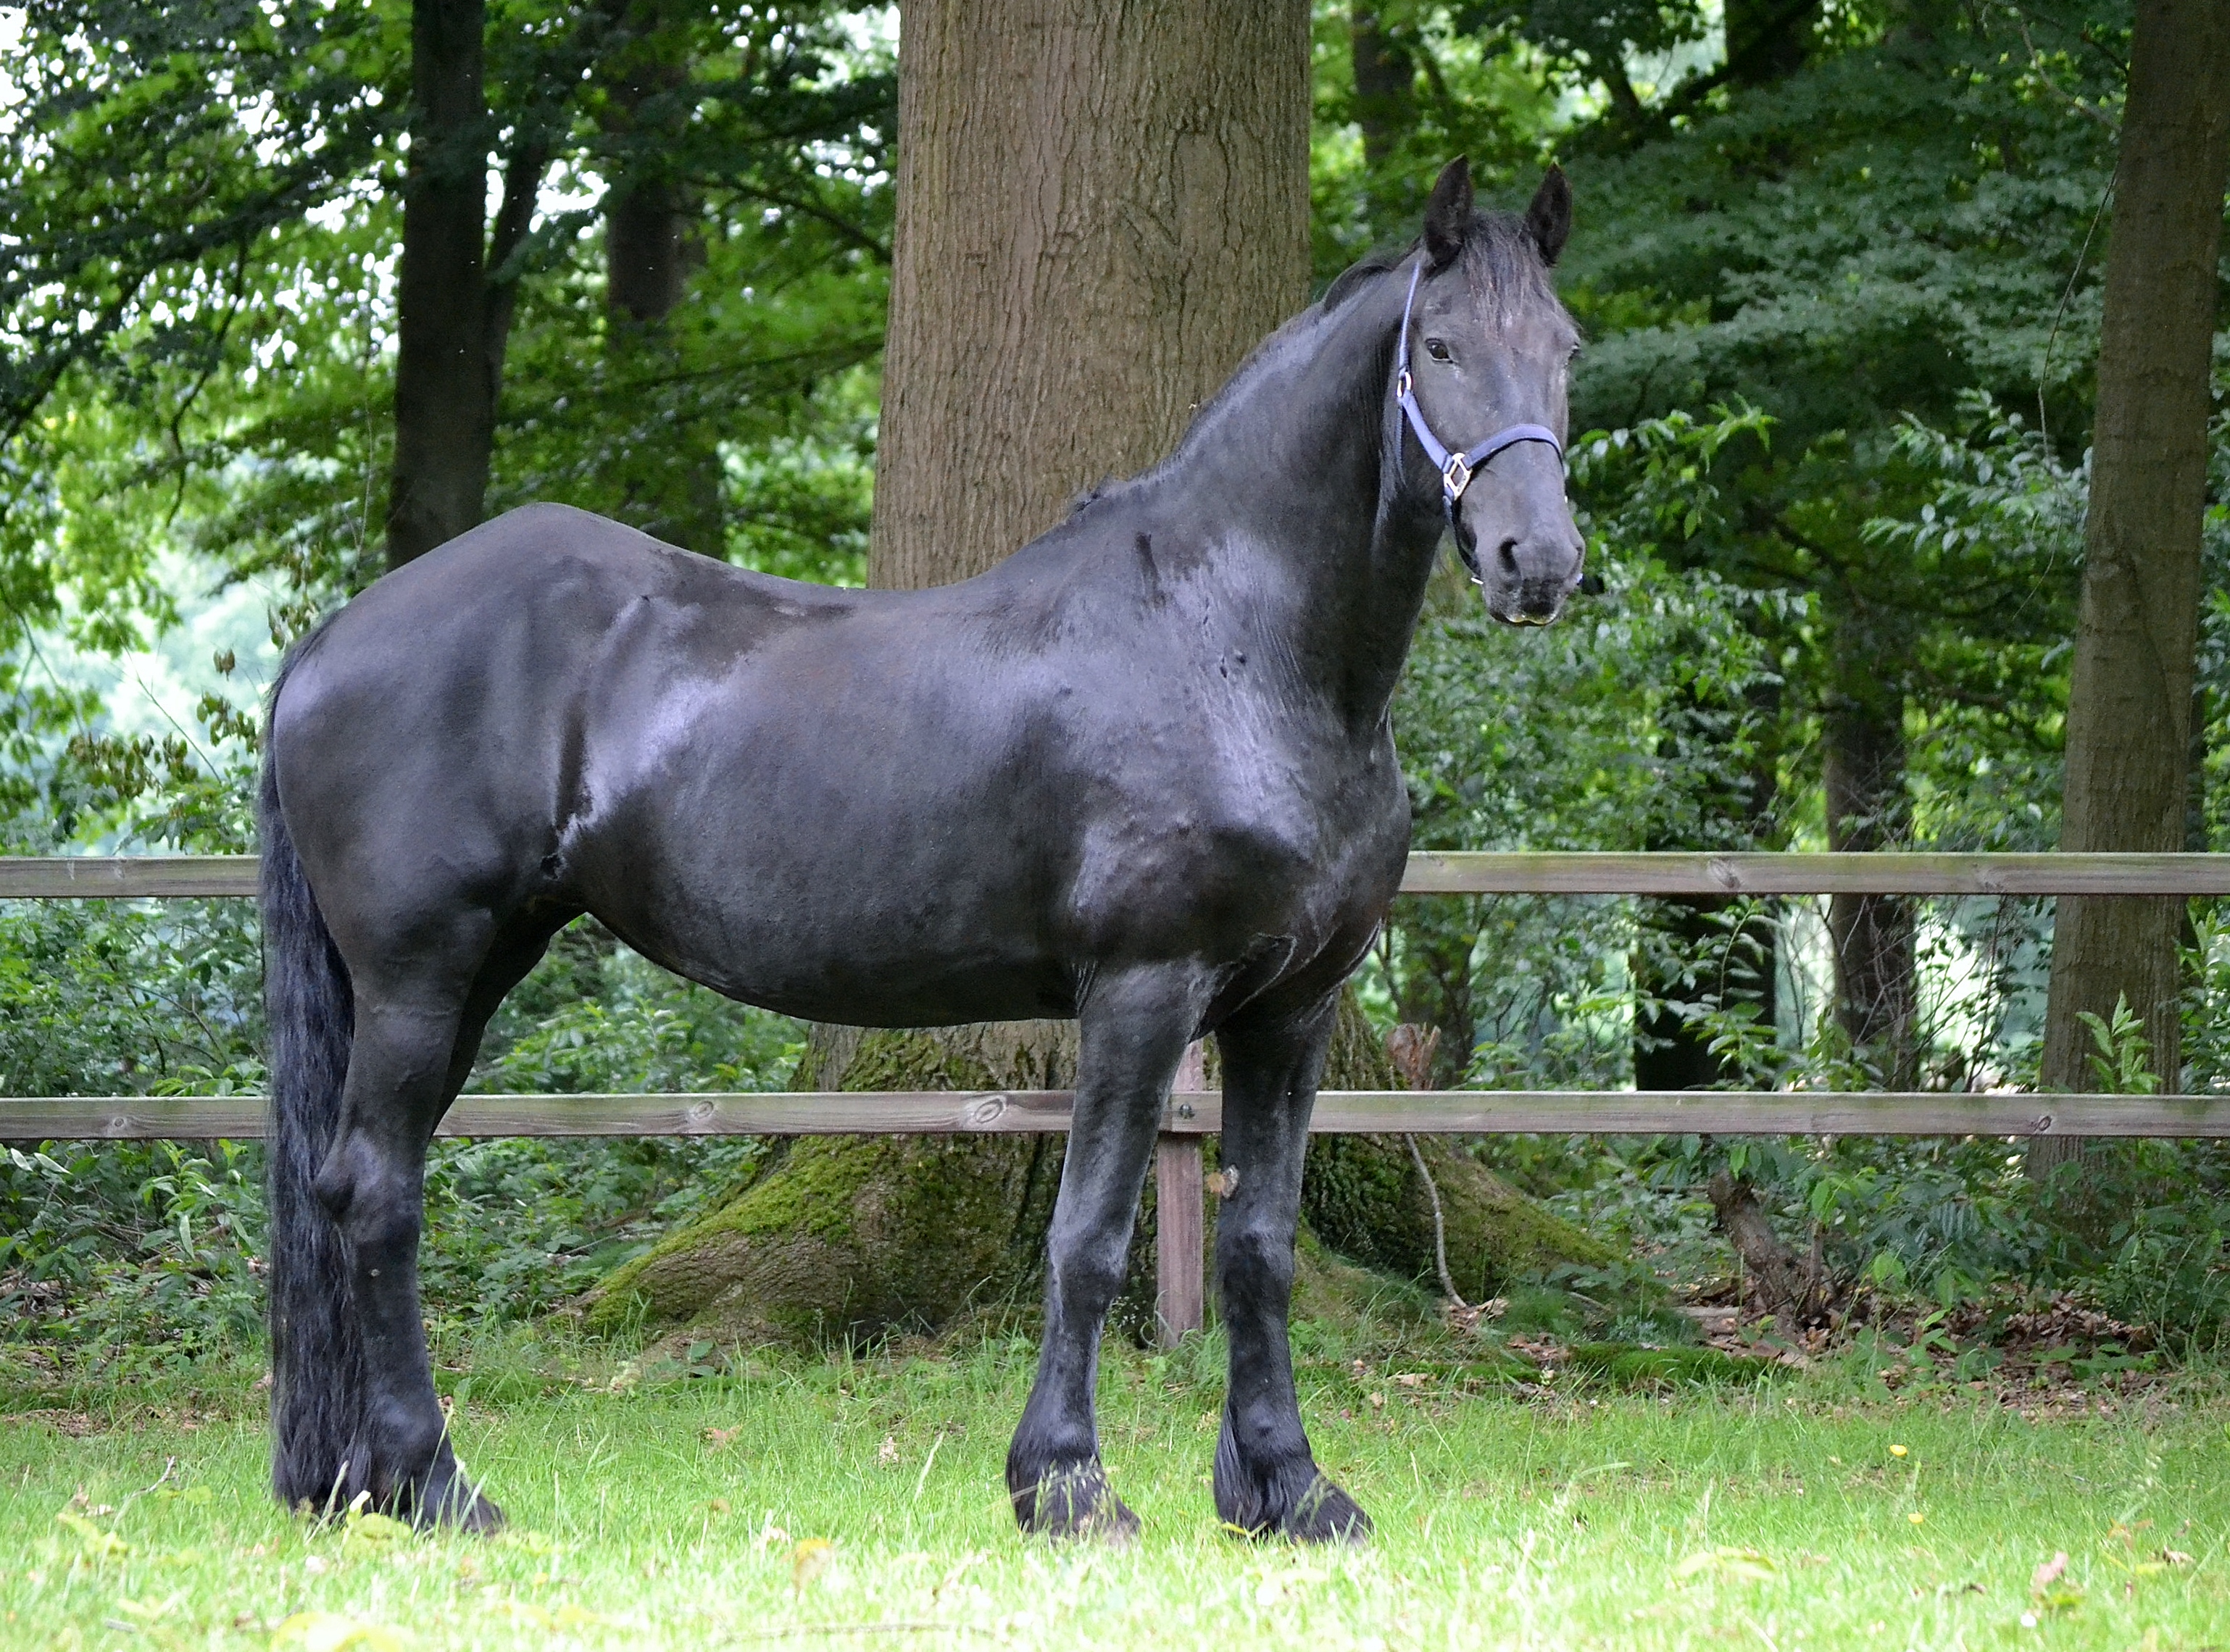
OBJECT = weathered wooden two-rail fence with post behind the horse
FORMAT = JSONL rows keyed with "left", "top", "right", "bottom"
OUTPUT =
{"left": 0, "top": 851, "right": 2230, "bottom": 1338}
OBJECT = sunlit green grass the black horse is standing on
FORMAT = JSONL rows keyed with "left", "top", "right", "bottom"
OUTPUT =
{"left": 0, "top": 1338, "right": 2230, "bottom": 1652}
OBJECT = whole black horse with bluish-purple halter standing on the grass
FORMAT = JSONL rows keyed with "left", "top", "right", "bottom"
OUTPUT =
{"left": 261, "top": 161, "right": 1581, "bottom": 1538}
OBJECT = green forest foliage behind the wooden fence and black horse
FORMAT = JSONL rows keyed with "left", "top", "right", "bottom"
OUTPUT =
{"left": 0, "top": 0, "right": 2230, "bottom": 1342}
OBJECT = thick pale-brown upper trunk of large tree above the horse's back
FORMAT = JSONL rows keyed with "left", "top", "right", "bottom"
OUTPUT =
{"left": 870, "top": 0, "right": 1309, "bottom": 588}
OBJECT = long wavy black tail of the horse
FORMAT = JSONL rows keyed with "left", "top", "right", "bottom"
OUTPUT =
{"left": 259, "top": 713, "right": 366, "bottom": 1507}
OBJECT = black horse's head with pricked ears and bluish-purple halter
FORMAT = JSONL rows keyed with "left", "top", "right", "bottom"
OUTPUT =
{"left": 1396, "top": 161, "right": 1584, "bottom": 625}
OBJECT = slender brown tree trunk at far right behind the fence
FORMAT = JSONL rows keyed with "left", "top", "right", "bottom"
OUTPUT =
{"left": 2029, "top": 0, "right": 2230, "bottom": 1175}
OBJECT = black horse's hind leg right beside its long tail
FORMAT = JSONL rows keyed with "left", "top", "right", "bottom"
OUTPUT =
{"left": 315, "top": 919, "right": 551, "bottom": 1532}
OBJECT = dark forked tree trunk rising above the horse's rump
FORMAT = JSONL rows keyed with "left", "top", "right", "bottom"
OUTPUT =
{"left": 388, "top": 0, "right": 549, "bottom": 569}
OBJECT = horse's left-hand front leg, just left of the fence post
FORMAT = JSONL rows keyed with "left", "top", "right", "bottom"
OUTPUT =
{"left": 1006, "top": 965, "right": 1199, "bottom": 1538}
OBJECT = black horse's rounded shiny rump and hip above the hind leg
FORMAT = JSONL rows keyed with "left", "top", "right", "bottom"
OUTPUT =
{"left": 270, "top": 506, "right": 861, "bottom": 946}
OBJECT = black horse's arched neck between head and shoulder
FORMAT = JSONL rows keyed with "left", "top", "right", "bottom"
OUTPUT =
{"left": 1170, "top": 277, "right": 1441, "bottom": 725}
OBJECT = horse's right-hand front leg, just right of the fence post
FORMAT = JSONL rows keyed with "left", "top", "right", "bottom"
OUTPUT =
{"left": 1215, "top": 998, "right": 1371, "bottom": 1543}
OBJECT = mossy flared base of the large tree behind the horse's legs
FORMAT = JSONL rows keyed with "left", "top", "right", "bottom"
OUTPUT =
{"left": 584, "top": 994, "right": 1613, "bottom": 1346}
